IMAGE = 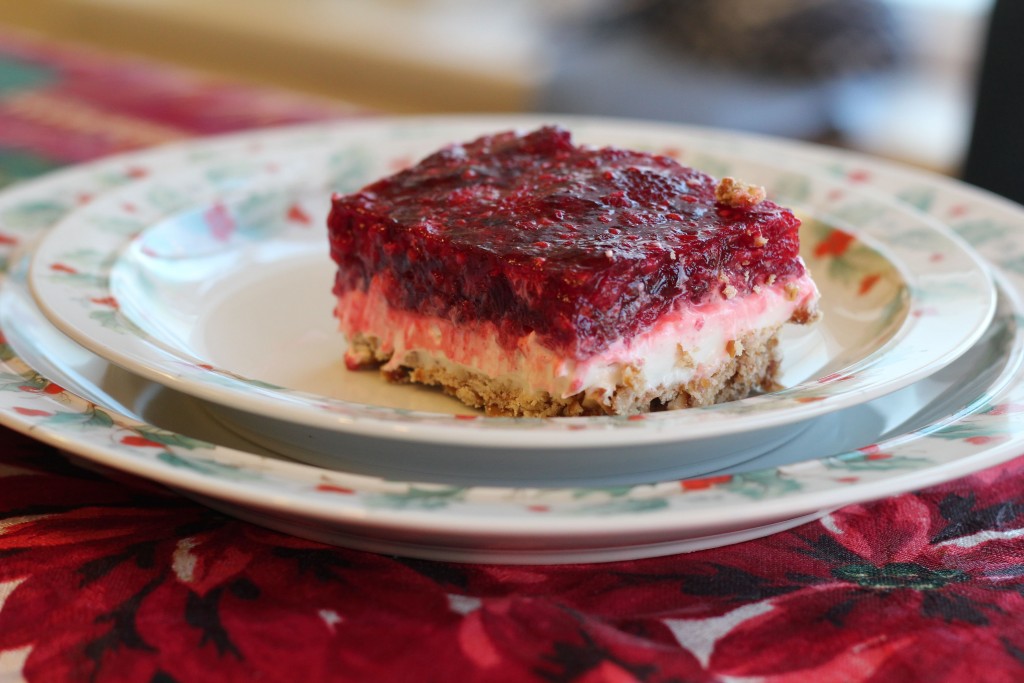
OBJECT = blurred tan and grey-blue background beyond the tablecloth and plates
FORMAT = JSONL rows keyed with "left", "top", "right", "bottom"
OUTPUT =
{"left": 0, "top": 0, "right": 999, "bottom": 175}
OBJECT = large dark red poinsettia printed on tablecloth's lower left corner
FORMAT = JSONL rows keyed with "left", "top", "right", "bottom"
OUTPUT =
{"left": 0, "top": 499, "right": 457, "bottom": 682}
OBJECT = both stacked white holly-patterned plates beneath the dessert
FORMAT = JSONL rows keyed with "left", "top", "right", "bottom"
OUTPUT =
{"left": 0, "top": 117, "right": 1024, "bottom": 562}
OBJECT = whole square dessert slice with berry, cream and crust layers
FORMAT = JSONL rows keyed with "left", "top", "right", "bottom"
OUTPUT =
{"left": 328, "top": 127, "right": 818, "bottom": 416}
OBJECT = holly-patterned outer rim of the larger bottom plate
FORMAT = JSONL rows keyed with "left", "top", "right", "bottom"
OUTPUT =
{"left": 0, "top": 116, "right": 1024, "bottom": 562}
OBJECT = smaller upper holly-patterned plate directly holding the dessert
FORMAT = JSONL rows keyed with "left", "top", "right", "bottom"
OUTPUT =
{"left": 31, "top": 119, "right": 994, "bottom": 485}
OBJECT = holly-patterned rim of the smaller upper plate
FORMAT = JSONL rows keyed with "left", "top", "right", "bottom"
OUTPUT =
{"left": 18, "top": 117, "right": 995, "bottom": 456}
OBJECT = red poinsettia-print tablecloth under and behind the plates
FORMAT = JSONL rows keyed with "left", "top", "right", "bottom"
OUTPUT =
{"left": 0, "top": 24, "right": 1024, "bottom": 683}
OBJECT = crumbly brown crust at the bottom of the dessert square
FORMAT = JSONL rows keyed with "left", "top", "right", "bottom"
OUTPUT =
{"left": 348, "top": 327, "right": 780, "bottom": 417}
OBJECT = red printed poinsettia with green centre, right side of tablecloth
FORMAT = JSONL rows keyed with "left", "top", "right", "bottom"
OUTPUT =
{"left": 663, "top": 485, "right": 1024, "bottom": 683}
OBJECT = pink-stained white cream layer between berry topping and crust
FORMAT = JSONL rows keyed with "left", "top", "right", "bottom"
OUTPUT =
{"left": 336, "top": 274, "right": 818, "bottom": 397}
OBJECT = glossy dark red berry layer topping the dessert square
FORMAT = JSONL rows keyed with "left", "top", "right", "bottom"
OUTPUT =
{"left": 328, "top": 127, "right": 804, "bottom": 358}
